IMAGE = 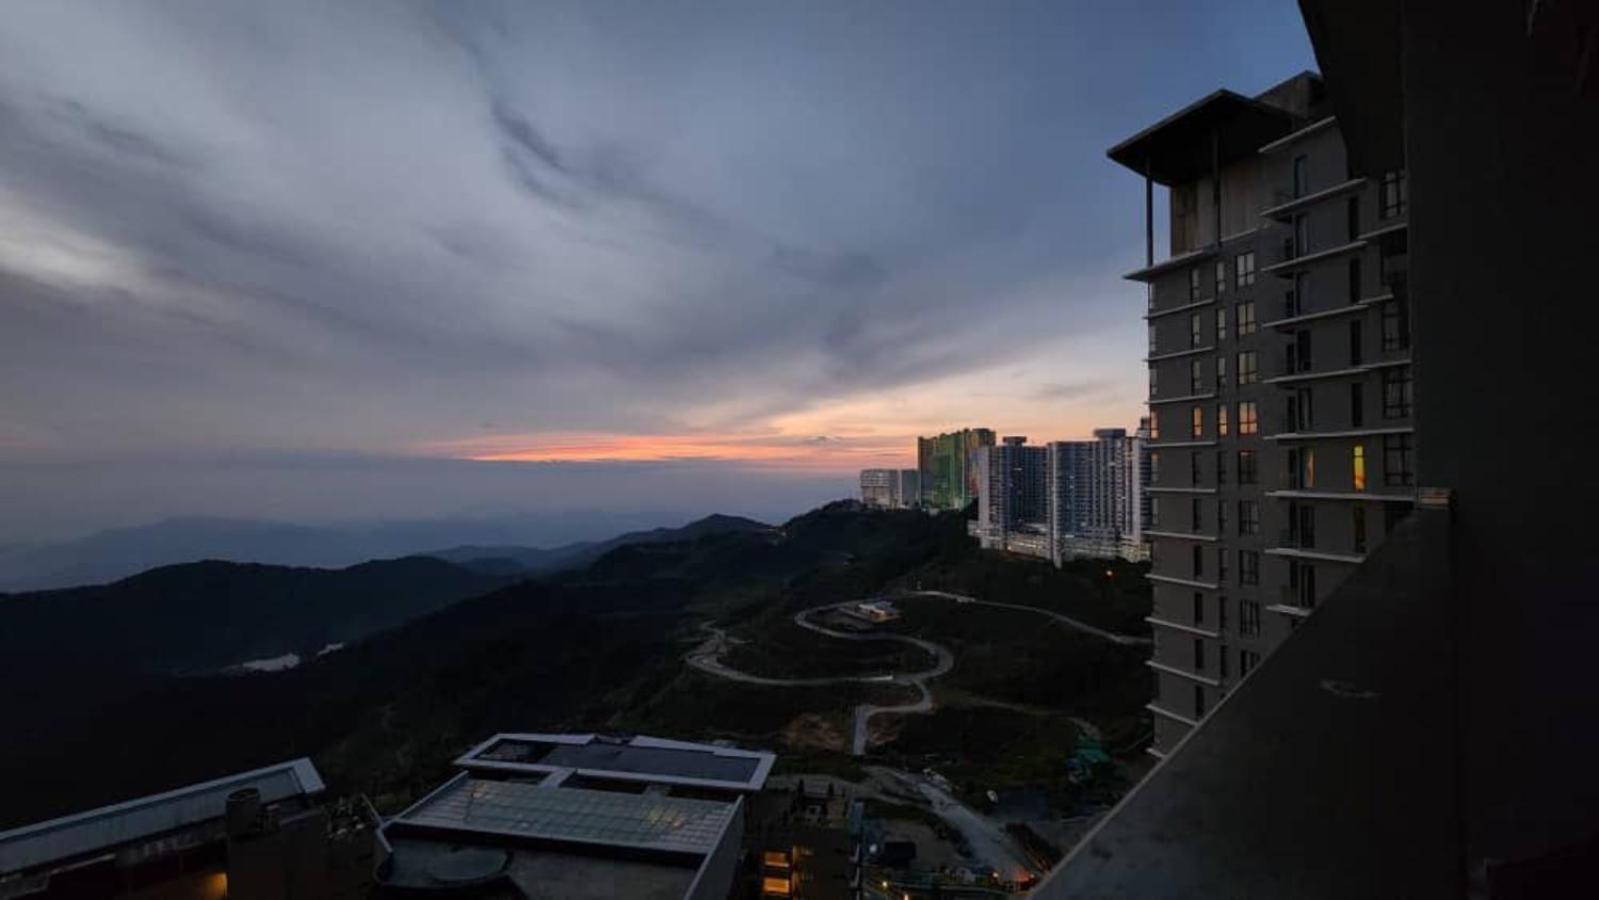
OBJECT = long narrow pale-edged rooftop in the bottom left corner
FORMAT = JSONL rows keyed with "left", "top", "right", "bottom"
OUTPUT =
{"left": 0, "top": 758, "right": 323, "bottom": 874}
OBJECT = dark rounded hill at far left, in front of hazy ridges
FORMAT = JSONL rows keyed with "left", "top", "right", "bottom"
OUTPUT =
{"left": 0, "top": 556, "right": 515, "bottom": 751}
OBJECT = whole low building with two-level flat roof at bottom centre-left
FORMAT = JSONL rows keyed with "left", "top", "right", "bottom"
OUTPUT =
{"left": 377, "top": 734, "right": 776, "bottom": 900}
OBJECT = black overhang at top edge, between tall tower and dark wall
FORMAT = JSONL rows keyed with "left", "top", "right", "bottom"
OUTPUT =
{"left": 1298, "top": 0, "right": 1404, "bottom": 176}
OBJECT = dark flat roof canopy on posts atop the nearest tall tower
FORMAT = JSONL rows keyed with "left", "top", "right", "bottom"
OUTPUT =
{"left": 1105, "top": 90, "right": 1298, "bottom": 187}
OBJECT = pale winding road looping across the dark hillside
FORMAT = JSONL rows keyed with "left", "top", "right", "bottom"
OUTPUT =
{"left": 686, "top": 590, "right": 1150, "bottom": 756}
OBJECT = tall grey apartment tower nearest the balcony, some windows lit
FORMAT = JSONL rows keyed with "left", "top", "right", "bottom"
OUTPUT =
{"left": 1110, "top": 72, "right": 1415, "bottom": 755}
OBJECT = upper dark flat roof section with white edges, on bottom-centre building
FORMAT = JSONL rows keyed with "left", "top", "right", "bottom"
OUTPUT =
{"left": 456, "top": 734, "right": 776, "bottom": 791}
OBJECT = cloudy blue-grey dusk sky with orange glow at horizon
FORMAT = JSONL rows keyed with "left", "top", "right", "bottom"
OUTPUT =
{"left": 0, "top": 0, "right": 1314, "bottom": 542}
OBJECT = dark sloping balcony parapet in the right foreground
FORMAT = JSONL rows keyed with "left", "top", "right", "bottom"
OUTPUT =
{"left": 1033, "top": 508, "right": 1463, "bottom": 900}
